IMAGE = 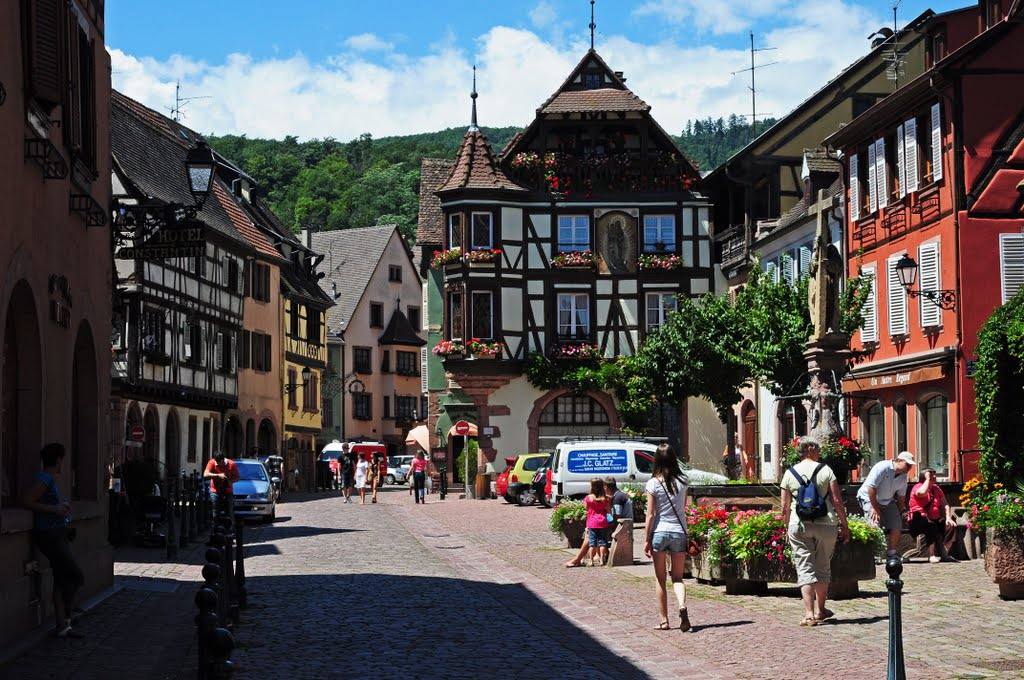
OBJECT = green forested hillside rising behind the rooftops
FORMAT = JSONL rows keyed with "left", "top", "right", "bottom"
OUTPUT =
{"left": 209, "top": 116, "right": 772, "bottom": 239}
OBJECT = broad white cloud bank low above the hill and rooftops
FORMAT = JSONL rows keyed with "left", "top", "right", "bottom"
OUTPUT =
{"left": 111, "top": 0, "right": 881, "bottom": 146}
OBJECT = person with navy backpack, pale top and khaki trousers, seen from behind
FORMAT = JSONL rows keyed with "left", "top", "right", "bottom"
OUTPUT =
{"left": 781, "top": 436, "right": 850, "bottom": 626}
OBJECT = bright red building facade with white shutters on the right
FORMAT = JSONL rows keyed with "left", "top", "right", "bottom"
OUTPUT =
{"left": 826, "top": 2, "right": 1024, "bottom": 479}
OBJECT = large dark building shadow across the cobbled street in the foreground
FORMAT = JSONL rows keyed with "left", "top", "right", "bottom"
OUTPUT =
{"left": 232, "top": 573, "right": 651, "bottom": 678}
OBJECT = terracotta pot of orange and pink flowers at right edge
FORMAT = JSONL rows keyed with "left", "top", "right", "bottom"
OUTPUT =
{"left": 961, "top": 478, "right": 1024, "bottom": 600}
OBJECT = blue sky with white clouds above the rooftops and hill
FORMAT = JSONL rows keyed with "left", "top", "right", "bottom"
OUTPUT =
{"left": 106, "top": 0, "right": 969, "bottom": 139}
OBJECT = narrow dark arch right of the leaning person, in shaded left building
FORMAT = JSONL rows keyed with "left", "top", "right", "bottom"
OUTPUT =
{"left": 68, "top": 321, "right": 99, "bottom": 500}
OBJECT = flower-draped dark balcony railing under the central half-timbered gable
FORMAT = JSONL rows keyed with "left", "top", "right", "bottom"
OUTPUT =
{"left": 509, "top": 152, "right": 696, "bottom": 198}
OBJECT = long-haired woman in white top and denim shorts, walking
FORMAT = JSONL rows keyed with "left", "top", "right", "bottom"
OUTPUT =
{"left": 643, "top": 443, "right": 690, "bottom": 633}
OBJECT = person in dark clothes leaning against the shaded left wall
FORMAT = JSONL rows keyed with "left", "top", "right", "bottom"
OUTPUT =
{"left": 22, "top": 443, "right": 85, "bottom": 638}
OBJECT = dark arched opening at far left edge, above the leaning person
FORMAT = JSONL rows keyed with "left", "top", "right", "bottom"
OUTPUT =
{"left": 0, "top": 281, "right": 43, "bottom": 506}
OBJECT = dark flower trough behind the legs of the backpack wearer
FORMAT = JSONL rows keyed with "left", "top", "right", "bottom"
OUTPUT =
{"left": 693, "top": 543, "right": 874, "bottom": 599}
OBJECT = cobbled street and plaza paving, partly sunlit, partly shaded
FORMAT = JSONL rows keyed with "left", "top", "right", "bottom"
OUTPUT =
{"left": 0, "top": 490, "right": 1024, "bottom": 680}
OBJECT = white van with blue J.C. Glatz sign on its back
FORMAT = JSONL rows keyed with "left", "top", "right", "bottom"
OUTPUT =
{"left": 550, "top": 439, "right": 728, "bottom": 505}
